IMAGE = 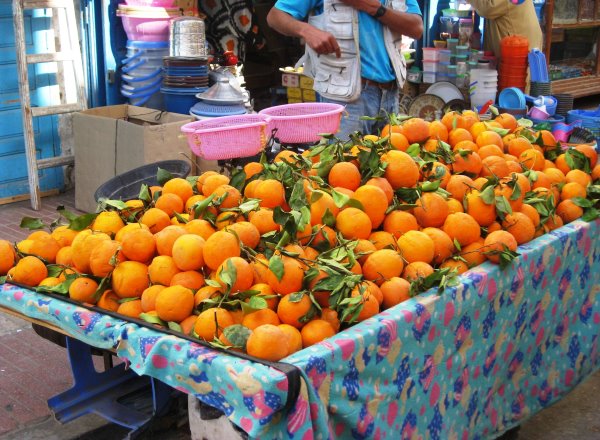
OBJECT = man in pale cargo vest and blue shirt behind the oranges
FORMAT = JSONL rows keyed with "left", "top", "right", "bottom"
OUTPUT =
{"left": 267, "top": 0, "right": 423, "bottom": 140}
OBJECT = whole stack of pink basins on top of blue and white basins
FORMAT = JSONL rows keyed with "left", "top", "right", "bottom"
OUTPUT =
{"left": 117, "top": 0, "right": 181, "bottom": 110}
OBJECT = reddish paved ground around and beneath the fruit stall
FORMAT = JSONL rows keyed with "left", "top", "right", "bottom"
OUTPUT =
{"left": 0, "top": 187, "right": 600, "bottom": 440}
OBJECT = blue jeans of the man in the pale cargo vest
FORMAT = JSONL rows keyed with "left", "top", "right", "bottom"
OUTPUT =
{"left": 323, "top": 84, "right": 400, "bottom": 141}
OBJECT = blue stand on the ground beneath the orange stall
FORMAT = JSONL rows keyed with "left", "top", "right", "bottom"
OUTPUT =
{"left": 48, "top": 337, "right": 173, "bottom": 438}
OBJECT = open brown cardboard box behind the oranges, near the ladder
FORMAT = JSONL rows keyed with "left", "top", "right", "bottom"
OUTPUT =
{"left": 73, "top": 104, "right": 194, "bottom": 212}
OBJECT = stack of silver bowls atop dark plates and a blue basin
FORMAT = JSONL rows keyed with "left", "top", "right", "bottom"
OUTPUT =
{"left": 160, "top": 17, "right": 208, "bottom": 114}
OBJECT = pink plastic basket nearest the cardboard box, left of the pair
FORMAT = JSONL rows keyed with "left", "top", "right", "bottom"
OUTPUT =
{"left": 181, "top": 114, "right": 269, "bottom": 160}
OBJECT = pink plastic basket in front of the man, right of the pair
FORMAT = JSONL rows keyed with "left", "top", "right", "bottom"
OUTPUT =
{"left": 258, "top": 102, "right": 344, "bottom": 144}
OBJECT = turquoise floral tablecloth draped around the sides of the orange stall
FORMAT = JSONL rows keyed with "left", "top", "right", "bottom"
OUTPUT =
{"left": 0, "top": 221, "right": 600, "bottom": 439}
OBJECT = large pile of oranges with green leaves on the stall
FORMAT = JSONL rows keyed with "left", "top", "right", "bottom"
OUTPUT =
{"left": 0, "top": 111, "right": 600, "bottom": 361}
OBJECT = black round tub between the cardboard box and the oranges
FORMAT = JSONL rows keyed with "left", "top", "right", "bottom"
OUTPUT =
{"left": 94, "top": 160, "right": 191, "bottom": 202}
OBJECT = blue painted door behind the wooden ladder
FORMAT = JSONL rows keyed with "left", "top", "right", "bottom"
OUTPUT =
{"left": 0, "top": 0, "right": 64, "bottom": 199}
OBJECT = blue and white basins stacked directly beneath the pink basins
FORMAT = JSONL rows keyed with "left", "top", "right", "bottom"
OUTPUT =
{"left": 121, "top": 41, "right": 169, "bottom": 110}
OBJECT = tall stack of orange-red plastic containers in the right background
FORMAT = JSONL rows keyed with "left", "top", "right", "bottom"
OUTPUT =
{"left": 498, "top": 35, "right": 529, "bottom": 91}
